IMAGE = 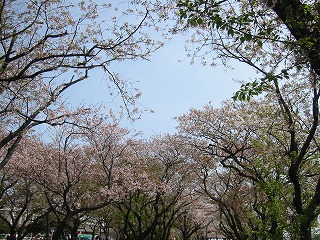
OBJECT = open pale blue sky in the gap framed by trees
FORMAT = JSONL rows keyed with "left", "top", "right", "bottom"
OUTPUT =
{"left": 65, "top": 31, "right": 255, "bottom": 138}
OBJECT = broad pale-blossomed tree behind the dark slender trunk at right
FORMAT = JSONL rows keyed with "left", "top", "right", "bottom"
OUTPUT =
{"left": 179, "top": 83, "right": 319, "bottom": 239}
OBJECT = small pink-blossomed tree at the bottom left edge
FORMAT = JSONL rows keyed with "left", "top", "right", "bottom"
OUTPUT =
{"left": 0, "top": 138, "right": 50, "bottom": 239}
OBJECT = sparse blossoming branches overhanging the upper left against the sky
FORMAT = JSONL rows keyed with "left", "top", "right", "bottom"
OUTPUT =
{"left": 0, "top": 0, "right": 170, "bottom": 169}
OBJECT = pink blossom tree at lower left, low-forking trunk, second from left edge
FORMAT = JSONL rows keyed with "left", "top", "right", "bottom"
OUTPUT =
{"left": 3, "top": 122, "right": 108, "bottom": 239}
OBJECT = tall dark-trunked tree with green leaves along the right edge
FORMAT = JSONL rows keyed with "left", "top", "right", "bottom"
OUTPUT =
{"left": 178, "top": 0, "right": 320, "bottom": 239}
